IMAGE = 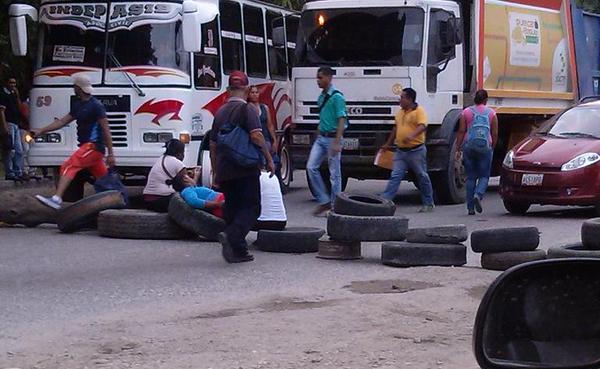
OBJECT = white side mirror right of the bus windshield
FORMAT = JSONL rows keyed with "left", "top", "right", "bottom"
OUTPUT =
{"left": 182, "top": 0, "right": 219, "bottom": 52}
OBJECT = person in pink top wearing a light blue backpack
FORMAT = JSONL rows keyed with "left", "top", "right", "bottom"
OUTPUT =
{"left": 456, "top": 90, "right": 498, "bottom": 215}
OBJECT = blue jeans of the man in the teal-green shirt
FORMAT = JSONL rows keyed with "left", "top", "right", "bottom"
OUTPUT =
{"left": 306, "top": 135, "right": 342, "bottom": 205}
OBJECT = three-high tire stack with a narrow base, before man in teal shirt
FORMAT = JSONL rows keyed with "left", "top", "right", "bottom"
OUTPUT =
{"left": 319, "top": 192, "right": 408, "bottom": 259}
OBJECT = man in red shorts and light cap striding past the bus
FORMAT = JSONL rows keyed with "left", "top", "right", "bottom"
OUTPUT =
{"left": 32, "top": 74, "right": 115, "bottom": 209}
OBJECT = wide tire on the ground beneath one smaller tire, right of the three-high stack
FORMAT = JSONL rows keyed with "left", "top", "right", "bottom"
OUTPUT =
{"left": 381, "top": 242, "right": 467, "bottom": 267}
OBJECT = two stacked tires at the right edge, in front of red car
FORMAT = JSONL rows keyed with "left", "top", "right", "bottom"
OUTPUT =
{"left": 548, "top": 218, "right": 600, "bottom": 259}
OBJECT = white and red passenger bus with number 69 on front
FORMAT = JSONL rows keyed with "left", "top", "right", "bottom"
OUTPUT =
{"left": 9, "top": 0, "right": 298, "bottom": 190}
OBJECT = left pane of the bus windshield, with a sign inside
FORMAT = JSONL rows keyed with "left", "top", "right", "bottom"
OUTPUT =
{"left": 36, "top": 23, "right": 104, "bottom": 69}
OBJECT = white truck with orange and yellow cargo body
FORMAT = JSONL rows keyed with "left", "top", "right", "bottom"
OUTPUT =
{"left": 290, "top": 0, "right": 577, "bottom": 203}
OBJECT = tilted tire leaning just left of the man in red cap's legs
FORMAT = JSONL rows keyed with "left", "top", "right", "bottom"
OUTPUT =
{"left": 169, "top": 193, "right": 225, "bottom": 241}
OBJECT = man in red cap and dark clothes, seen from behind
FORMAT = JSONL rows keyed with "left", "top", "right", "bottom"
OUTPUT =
{"left": 210, "top": 71, "right": 275, "bottom": 263}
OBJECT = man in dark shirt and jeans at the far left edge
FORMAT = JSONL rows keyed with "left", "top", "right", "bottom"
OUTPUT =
{"left": 0, "top": 77, "right": 25, "bottom": 181}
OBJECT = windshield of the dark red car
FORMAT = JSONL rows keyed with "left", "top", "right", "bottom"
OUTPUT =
{"left": 537, "top": 106, "right": 600, "bottom": 138}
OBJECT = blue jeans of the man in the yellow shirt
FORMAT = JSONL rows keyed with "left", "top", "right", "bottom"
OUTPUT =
{"left": 383, "top": 145, "right": 433, "bottom": 205}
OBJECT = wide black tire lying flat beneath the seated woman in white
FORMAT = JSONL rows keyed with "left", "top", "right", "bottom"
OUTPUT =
{"left": 98, "top": 209, "right": 190, "bottom": 240}
